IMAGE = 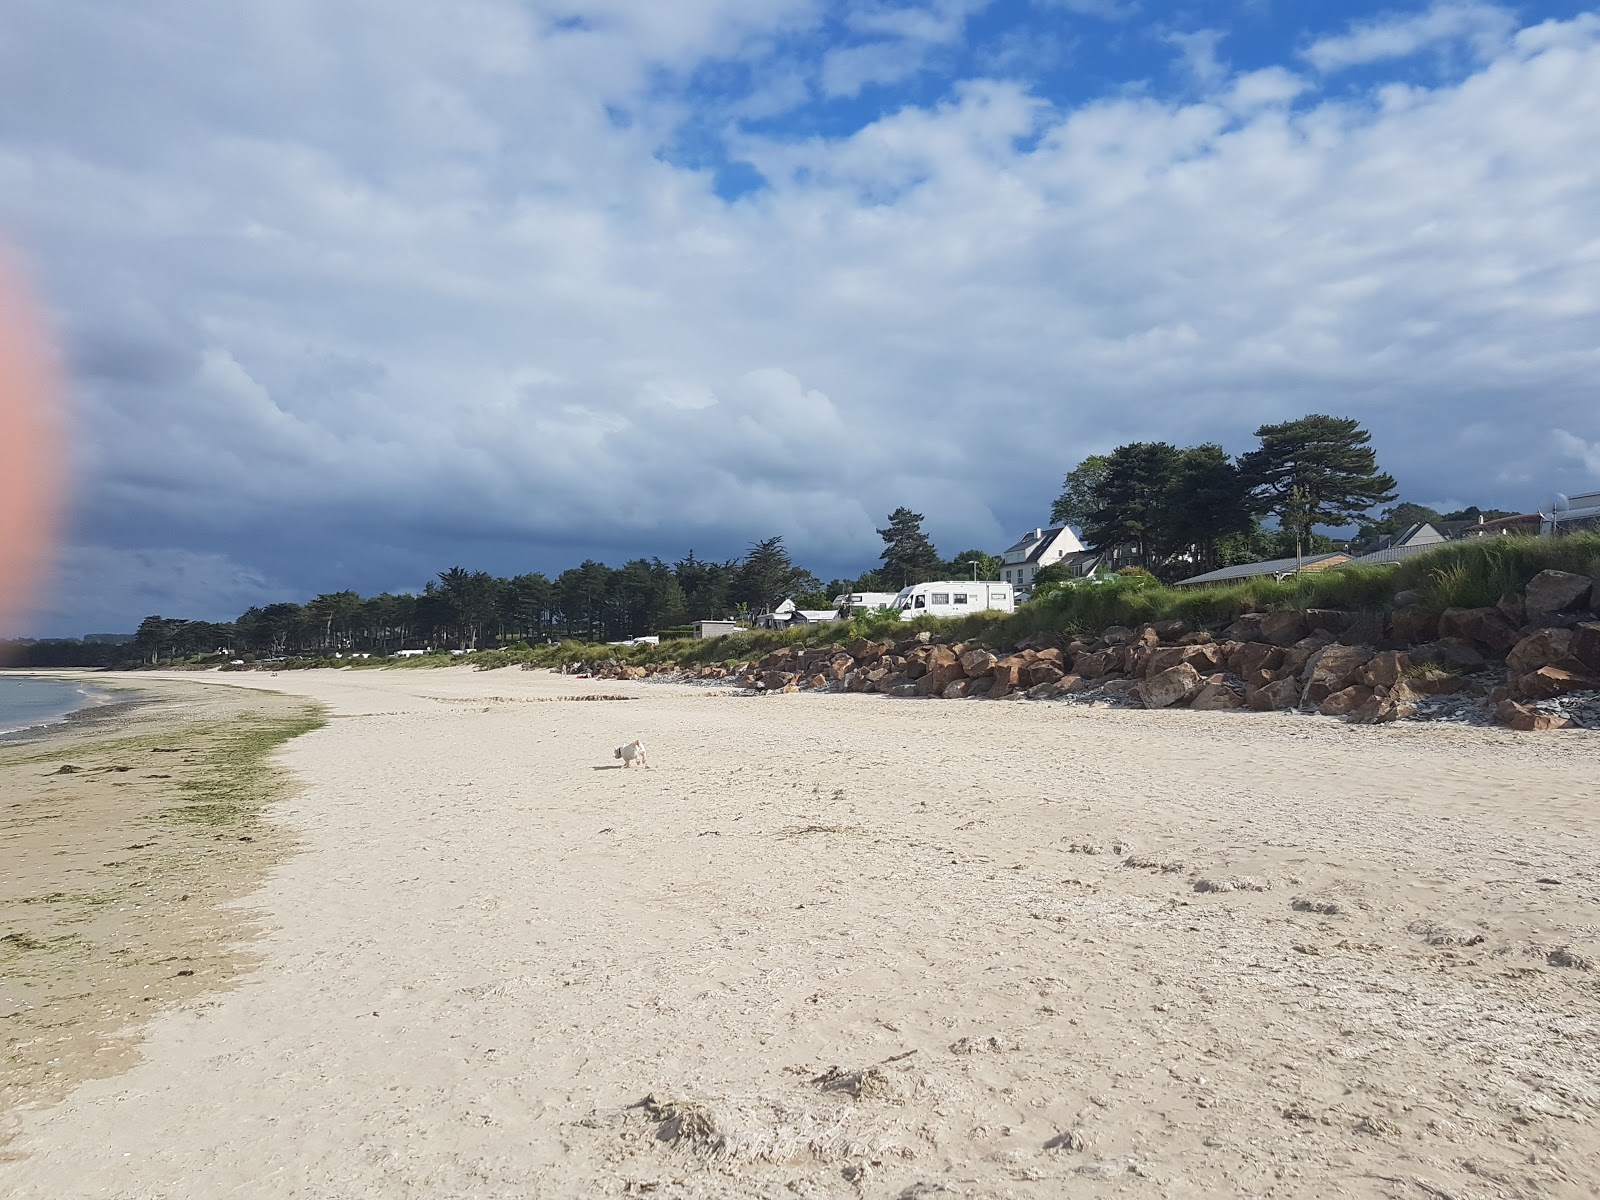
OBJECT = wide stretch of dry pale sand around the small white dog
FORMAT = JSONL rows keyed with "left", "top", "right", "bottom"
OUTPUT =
{"left": 0, "top": 669, "right": 1600, "bottom": 1200}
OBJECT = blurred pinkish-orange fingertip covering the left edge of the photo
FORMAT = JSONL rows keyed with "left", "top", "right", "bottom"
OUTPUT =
{"left": 0, "top": 246, "right": 61, "bottom": 649}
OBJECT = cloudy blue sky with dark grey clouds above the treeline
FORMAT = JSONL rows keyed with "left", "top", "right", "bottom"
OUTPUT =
{"left": 0, "top": 0, "right": 1600, "bottom": 635}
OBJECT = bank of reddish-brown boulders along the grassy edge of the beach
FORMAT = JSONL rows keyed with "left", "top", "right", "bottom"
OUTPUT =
{"left": 597, "top": 571, "right": 1600, "bottom": 731}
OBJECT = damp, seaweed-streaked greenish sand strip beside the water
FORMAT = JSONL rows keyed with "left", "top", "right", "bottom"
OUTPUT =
{"left": 0, "top": 675, "right": 324, "bottom": 1162}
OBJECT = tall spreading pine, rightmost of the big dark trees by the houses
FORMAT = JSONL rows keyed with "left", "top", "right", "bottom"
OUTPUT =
{"left": 1238, "top": 413, "right": 1395, "bottom": 557}
